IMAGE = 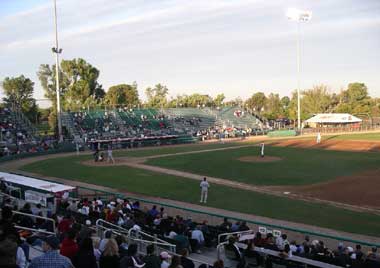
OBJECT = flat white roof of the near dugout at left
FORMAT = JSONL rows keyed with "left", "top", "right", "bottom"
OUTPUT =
{"left": 0, "top": 172, "right": 75, "bottom": 193}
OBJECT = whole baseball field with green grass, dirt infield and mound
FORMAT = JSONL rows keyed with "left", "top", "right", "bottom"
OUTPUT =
{"left": 10, "top": 133, "right": 380, "bottom": 236}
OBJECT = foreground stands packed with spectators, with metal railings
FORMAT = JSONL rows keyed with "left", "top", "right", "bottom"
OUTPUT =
{"left": 0, "top": 187, "right": 380, "bottom": 268}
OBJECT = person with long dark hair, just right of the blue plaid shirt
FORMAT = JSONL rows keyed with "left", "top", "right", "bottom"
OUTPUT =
{"left": 73, "top": 237, "right": 98, "bottom": 268}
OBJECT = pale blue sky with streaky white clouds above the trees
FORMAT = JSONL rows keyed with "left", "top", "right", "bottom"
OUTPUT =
{"left": 0, "top": 0, "right": 380, "bottom": 107}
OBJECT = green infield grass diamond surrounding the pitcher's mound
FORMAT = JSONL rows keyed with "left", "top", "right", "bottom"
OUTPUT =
{"left": 147, "top": 146, "right": 379, "bottom": 185}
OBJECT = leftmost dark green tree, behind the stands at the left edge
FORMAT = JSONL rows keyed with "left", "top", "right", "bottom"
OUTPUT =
{"left": 3, "top": 75, "right": 38, "bottom": 122}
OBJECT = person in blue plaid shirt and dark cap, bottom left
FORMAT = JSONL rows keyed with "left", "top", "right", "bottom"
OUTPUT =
{"left": 29, "top": 235, "right": 74, "bottom": 268}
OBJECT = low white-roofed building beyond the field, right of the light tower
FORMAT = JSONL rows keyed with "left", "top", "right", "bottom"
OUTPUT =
{"left": 305, "top": 113, "right": 362, "bottom": 128}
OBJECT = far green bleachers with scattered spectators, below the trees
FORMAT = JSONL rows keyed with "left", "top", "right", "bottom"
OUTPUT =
{"left": 63, "top": 107, "right": 260, "bottom": 140}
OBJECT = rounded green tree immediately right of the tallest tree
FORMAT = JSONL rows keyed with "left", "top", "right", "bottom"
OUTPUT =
{"left": 105, "top": 82, "right": 140, "bottom": 106}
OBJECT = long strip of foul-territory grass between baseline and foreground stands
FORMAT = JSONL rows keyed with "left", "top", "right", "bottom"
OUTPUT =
{"left": 21, "top": 156, "right": 380, "bottom": 236}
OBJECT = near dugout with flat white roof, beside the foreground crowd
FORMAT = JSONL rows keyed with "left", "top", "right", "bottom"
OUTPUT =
{"left": 0, "top": 172, "right": 77, "bottom": 211}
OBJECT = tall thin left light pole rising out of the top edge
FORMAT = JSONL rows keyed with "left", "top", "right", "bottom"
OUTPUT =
{"left": 52, "top": 0, "right": 63, "bottom": 142}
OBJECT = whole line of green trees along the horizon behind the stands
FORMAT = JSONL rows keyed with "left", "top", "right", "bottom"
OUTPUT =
{"left": 3, "top": 58, "right": 380, "bottom": 129}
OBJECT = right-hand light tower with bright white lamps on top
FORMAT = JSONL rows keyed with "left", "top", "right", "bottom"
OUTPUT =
{"left": 286, "top": 8, "right": 312, "bottom": 130}
